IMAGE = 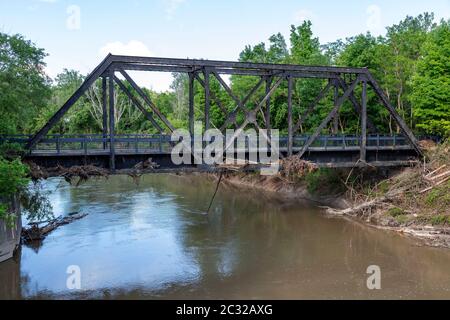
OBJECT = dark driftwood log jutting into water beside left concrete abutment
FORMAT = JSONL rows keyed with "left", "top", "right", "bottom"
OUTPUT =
{"left": 22, "top": 212, "right": 88, "bottom": 243}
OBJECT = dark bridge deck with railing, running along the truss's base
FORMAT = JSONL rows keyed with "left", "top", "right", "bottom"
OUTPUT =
{"left": 0, "top": 134, "right": 422, "bottom": 167}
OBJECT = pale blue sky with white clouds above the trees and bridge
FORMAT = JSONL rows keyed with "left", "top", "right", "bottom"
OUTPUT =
{"left": 0, "top": 0, "right": 450, "bottom": 90}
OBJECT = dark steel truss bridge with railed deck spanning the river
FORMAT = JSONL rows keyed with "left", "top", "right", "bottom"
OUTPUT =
{"left": 0, "top": 55, "right": 422, "bottom": 171}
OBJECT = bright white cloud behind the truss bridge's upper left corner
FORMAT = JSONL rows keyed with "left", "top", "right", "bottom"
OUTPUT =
{"left": 98, "top": 40, "right": 173, "bottom": 91}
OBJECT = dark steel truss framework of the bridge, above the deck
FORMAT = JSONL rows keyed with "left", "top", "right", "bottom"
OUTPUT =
{"left": 27, "top": 54, "right": 422, "bottom": 169}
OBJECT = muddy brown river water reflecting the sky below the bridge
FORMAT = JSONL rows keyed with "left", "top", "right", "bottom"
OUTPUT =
{"left": 0, "top": 174, "right": 450, "bottom": 299}
